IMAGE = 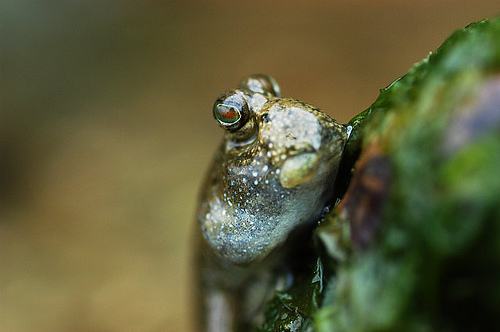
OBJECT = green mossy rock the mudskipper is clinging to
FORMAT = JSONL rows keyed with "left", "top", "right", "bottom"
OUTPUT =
{"left": 260, "top": 19, "right": 500, "bottom": 332}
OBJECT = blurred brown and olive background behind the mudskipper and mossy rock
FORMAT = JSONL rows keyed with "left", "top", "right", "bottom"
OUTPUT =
{"left": 0, "top": 0, "right": 500, "bottom": 332}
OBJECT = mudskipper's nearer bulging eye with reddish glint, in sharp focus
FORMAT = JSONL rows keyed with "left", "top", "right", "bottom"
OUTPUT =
{"left": 213, "top": 92, "right": 250, "bottom": 131}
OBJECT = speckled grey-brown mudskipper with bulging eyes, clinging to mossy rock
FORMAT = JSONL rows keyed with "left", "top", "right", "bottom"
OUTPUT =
{"left": 197, "top": 75, "right": 348, "bottom": 331}
